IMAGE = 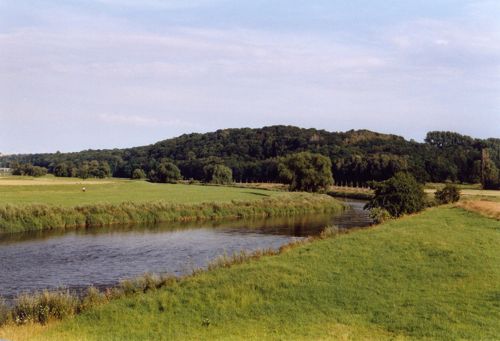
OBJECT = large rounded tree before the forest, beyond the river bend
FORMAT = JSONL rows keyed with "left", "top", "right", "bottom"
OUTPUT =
{"left": 278, "top": 152, "right": 333, "bottom": 192}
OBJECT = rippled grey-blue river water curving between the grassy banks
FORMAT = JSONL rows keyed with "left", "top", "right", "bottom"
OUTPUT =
{"left": 0, "top": 200, "right": 371, "bottom": 299}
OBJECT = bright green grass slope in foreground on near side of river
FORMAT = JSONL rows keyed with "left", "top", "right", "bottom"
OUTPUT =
{"left": 0, "top": 207, "right": 500, "bottom": 340}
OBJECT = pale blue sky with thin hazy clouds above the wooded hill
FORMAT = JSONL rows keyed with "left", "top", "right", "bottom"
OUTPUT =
{"left": 0, "top": 0, "right": 500, "bottom": 154}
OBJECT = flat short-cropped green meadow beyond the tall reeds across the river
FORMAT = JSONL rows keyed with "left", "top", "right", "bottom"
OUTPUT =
{"left": 0, "top": 177, "right": 284, "bottom": 206}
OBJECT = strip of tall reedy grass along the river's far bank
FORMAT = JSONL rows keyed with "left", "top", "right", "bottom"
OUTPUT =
{"left": 0, "top": 193, "right": 343, "bottom": 233}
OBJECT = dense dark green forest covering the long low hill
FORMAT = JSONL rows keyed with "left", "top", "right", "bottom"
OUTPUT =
{"left": 0, "top": 126, "right": 500, "bottom": 187}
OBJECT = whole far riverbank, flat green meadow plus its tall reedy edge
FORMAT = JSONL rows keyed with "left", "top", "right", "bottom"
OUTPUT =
{"left": 0, "top": 177, "right": 342, "bottom": 233}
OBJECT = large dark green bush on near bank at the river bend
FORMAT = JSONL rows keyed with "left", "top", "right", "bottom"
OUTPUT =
{"left": 366, "top": 173, "right": 426, "bottom": 217}
